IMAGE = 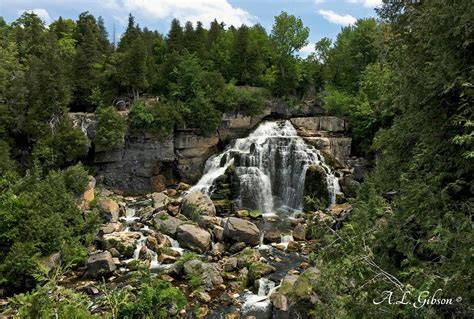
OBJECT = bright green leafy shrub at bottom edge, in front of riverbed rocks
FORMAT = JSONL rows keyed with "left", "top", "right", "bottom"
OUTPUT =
{"left": 117, "top": 276, "right": 187, "bottom": 318}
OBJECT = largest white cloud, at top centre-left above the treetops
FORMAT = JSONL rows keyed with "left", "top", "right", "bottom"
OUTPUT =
{"left": 105, "top": 0, "right": 256, "bottom": 26}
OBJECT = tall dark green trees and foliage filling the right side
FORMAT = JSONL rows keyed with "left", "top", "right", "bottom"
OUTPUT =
{"left": 314, "top": 2, "right": 474, "bottom": 318}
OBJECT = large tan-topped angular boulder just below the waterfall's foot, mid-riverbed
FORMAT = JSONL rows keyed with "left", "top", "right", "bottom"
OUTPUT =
{"left": 224, "top": 217, "right": 260, "bottom": 246}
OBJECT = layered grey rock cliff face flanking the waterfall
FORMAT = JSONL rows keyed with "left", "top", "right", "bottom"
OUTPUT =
{"left": 70, "top": 101, "right": 351, "bottom": 194}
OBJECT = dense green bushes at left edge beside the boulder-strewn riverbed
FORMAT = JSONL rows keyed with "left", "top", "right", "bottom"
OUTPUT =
{"left": 0, "top": 165, "right": 98, "bottom": 292}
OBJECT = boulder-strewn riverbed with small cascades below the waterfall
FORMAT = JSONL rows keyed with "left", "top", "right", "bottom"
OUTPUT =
{"left": 39, "top": 177, "right": 350, "bottom": 318}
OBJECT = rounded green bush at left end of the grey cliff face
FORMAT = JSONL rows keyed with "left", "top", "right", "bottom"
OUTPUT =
{"left": 94, "top": 106, "right": 127, "bottom": 152}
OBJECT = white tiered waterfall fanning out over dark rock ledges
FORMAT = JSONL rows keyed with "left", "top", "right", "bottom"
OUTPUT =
{"left": 191, "top": 121, "right": 339, "bottom": 215}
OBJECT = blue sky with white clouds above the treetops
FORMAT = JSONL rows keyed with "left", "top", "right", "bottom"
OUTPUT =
{"left": 0, "top": 0, "right": 382, "bottom": 56}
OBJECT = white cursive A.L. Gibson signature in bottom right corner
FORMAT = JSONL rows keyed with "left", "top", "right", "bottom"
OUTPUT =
{"left": 372, "top": 289, "right": 462, "bottom": 309}
